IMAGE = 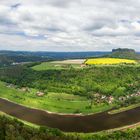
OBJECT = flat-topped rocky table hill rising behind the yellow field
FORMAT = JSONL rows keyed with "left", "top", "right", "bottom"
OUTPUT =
{"left": 106, "top": 48, "right": 140, "bottom": 59}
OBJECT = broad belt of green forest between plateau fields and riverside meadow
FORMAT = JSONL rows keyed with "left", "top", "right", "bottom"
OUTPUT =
{"left": 0, "top": 66, "right": 140, "bottom": 97}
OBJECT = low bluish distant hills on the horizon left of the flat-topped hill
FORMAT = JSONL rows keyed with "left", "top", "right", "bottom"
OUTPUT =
{"left": 0, "top": 51, "right": 109, "bottom": 67}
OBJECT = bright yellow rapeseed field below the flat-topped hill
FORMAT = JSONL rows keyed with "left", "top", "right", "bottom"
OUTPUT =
{"left": 85, "top": 58, "right": 137, "bottom": 65}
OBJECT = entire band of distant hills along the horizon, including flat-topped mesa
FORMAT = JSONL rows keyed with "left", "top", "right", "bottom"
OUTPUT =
{"left": 0, "top": 48, "right": 140, "bottom": 67}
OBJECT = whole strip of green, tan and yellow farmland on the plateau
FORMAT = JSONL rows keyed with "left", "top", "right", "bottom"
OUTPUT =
{"left": 32, "top": 58, "right": 138, "bottom": 71}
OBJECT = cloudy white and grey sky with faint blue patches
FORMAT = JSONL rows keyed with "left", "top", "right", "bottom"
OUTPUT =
{"left": 0, "top": 0, "right": 140, "bottom": 51}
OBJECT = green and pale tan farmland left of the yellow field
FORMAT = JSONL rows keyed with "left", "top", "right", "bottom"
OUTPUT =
{"left": 32, "top": 59, "right": 85, "bottom": 71}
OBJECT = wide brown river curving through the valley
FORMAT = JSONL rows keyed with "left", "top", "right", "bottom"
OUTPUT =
{"left": 0, "top": 98, "right": 140, "bottom": 133}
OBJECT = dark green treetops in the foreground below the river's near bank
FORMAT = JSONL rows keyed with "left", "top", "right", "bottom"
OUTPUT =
{"left": 0, "top": 115, "right": 140, "bottom": 140}
